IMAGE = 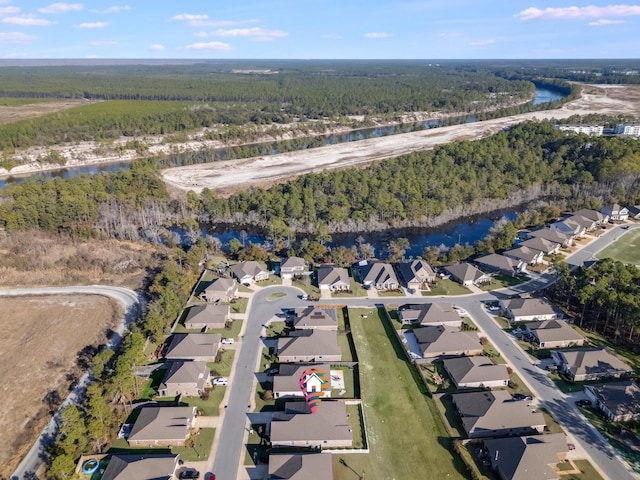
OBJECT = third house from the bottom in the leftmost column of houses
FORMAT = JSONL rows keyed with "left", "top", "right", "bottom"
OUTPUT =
{"left": 158, "top": 360, "right": 211, "bottom": 397}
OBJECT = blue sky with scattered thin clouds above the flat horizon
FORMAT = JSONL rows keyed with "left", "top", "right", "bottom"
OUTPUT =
{"left": 0, "top": 0, "right": 640, "bottom": 59}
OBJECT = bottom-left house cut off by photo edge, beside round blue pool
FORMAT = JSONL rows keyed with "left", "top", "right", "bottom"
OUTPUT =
{"left": 101, "top": 453, "right": 179, "bottom": 480}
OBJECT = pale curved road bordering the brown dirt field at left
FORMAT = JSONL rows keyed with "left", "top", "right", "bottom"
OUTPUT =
{"left": 0, "top": 285, "right": 141, "bottom": 480}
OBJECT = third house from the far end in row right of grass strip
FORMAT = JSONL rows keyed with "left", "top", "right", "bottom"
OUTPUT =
{"left": 442, "top": 356, "right": 509, "bottom": 388}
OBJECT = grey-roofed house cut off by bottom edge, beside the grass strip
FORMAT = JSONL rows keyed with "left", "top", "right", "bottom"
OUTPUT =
{"left": 269, "top": 453, "right": 333, "bottom": 480}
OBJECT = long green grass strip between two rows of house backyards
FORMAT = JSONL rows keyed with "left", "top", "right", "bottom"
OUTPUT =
{"left": 334, "top": 309, "right": 466, "bottom": 480}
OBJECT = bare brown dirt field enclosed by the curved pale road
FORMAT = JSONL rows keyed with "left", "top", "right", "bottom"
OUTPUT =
{"left": 0, "top": 295, "right": 121, "bottom": 478}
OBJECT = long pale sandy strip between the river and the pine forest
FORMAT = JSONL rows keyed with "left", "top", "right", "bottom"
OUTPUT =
{"left": 162, "top": 85, "right": 640, "bottom": 195}
